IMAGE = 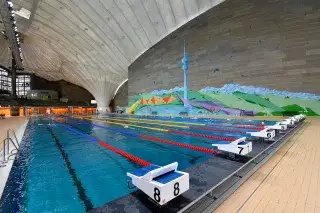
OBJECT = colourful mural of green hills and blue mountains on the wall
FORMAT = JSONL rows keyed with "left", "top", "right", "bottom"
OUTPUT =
{"left": 126, "top": 84, "right": 320, "bottom": 116}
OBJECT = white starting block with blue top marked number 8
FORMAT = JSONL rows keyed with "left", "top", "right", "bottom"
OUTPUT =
{"left": 127, "top": 162, "right": 189, "bottom": 206}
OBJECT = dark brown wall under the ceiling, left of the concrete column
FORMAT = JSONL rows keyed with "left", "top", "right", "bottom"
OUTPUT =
{"left": 31, "top": 75, "right": 94, "bottom": 103}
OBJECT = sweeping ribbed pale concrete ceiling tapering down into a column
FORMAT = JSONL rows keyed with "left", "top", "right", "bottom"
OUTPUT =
{"left": 0, "top": 0, "right": 224, "bottom": 107}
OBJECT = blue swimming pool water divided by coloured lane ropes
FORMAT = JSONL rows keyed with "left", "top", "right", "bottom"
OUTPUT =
{"left": 0, "top": 116, "right": 271, "bottom": 213}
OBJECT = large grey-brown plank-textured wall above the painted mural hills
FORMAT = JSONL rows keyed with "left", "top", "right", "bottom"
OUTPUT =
{"left": 128, "top": 0, "right": 320, "bottom": 100}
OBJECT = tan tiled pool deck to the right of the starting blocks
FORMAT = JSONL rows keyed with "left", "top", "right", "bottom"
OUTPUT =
{"left": 215, "top": 118, "right": 320, "bottom": 213}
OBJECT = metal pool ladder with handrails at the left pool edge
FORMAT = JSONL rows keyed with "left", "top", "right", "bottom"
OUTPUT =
{"left": 0, "top": 129, "right": 20, "bottom": 167}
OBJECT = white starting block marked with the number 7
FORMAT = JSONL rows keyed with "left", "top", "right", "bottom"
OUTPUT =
{"left": 212, "top": 137, "right": 252, "bottom": 155}
